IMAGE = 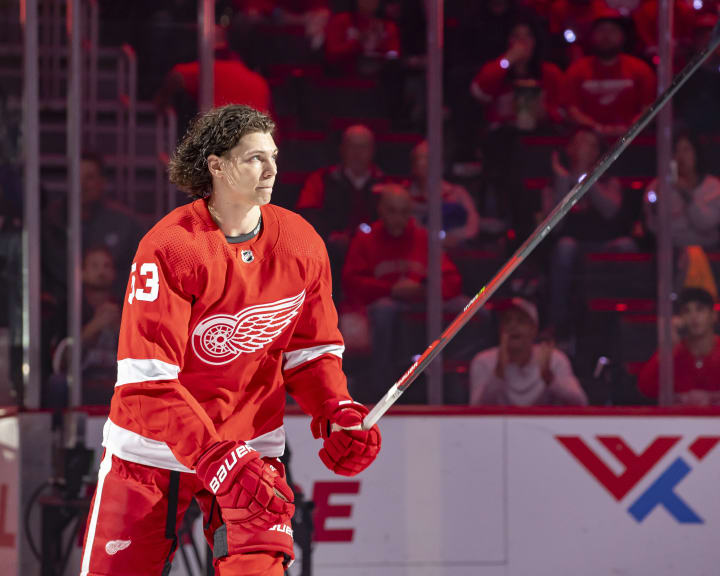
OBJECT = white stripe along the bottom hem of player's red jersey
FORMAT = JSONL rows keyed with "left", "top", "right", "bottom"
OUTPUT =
{"left": 103, "top": 418, "right": 285, "bottom": 474}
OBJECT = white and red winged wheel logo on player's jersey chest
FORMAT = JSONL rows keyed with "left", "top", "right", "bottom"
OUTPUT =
{"left": 192, "top": 290, "right": 305, "bottom": 365}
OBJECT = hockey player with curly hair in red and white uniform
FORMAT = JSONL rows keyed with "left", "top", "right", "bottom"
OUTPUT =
{"left": 81, "top": 105, "right": 380, "bottom": 576}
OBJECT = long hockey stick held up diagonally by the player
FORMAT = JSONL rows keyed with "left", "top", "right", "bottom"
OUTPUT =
{"left": 363, "top": 21, "right": 720, "bottom": 430}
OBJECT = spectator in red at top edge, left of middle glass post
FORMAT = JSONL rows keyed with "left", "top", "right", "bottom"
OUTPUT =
{"left": 325, "top": 0, "right": 400, "bottom": 73}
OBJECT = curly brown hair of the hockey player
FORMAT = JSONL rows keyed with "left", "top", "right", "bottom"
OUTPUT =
{"left": 168, "top": 104, "right": 275, "bottom": 198}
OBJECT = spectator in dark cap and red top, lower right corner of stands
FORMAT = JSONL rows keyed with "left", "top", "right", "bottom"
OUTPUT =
{"left": 638, "top": 288, "right": 720, "bottom": 406}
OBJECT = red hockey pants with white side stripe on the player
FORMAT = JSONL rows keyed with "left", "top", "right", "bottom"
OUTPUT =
{"left": 80, "top": 452, "right": 292, "bottom": 576}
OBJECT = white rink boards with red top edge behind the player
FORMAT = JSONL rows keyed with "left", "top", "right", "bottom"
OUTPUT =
{"left": 0, "top": 410, "right": 720, "bottom": 576}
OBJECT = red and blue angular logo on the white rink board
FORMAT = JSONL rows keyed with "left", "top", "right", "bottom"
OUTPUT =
{"left": 556, "top": 436, "right": 720, "bottom": 524}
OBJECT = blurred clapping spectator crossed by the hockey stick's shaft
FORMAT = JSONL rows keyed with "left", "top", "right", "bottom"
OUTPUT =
{"left": 543, "top": 128, "right": 637, "bottom": 339}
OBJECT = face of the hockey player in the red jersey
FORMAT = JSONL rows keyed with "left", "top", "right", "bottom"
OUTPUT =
{"left": 221, "top": 132, "right": 278, "bottom": 206}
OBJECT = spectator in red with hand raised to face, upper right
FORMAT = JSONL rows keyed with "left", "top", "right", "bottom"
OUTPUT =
{"left": 471, "top": 20, "right": 563, "bottom": 131}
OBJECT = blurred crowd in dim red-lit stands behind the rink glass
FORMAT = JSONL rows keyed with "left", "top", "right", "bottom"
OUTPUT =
{"left": 0, "top": 0, "right": 720, "bottom": 407}
